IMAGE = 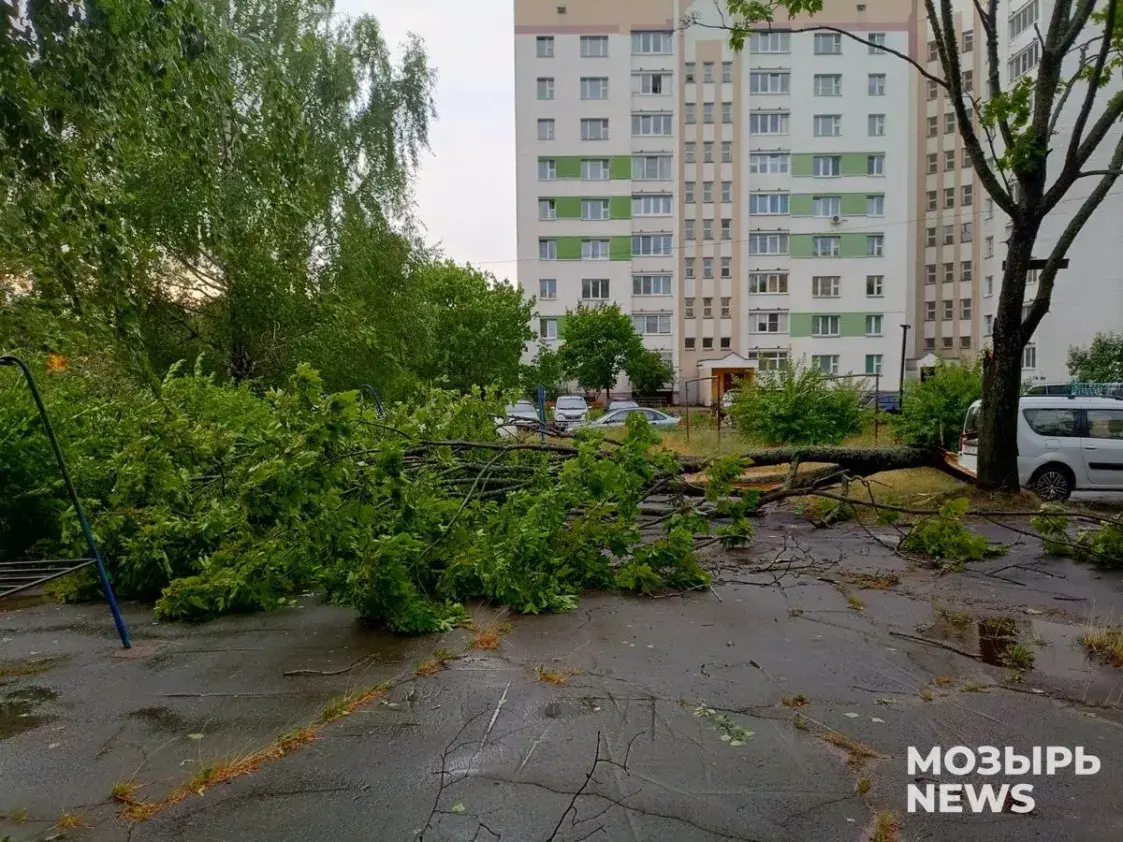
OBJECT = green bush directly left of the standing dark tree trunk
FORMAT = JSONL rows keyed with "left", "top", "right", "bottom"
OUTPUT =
{"left": 893, "top": 361, "right": 983, "bottom": 451}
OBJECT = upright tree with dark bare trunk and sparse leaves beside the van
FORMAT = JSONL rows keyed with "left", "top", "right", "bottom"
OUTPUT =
{"left": 705, "top": 0, "right": 1123, "bottom": 491}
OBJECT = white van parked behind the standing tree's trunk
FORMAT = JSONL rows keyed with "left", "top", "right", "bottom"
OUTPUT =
{"left": 959, "top": 395, "right": 1123, "bottom": 501}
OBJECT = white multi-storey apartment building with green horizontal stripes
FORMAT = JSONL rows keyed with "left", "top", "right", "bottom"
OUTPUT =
{"left": 515, "top": 0, "right": 917, "bottom": 401}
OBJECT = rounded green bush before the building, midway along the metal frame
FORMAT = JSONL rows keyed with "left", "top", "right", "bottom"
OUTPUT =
{"left": 729, "top": 363, "right": 867, "bottom": 445}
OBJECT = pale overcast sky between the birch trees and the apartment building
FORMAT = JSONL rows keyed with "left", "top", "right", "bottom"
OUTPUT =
{"left": 337, "top": 0, "right": 517, "bottom": 282}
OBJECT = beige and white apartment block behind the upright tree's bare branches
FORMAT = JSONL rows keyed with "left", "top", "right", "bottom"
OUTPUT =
{"left": 913, "top": 0, "right": 1123, "bottom": 382}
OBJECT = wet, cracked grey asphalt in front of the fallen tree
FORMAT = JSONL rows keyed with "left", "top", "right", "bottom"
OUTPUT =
{"left": 0, "top": 513, "right": 1123, "bottom": 842}
